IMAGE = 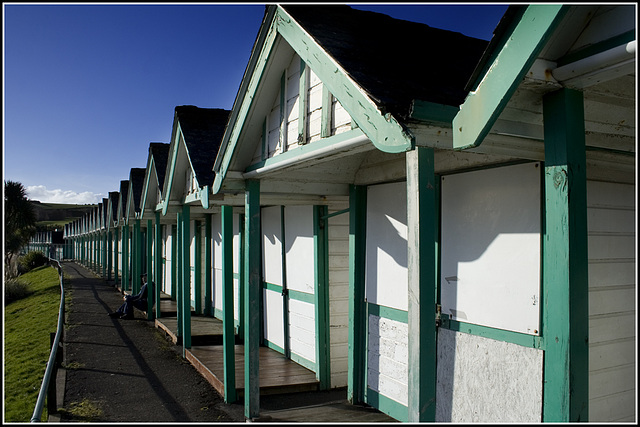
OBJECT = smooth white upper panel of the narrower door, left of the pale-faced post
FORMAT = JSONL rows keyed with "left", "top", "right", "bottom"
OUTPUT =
{"left": 365, "top": 182, "right": 408, "bottom": 311}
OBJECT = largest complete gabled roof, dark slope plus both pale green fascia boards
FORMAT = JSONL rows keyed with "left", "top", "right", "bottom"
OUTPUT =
{"left": 213, "top": 4, "right": 488, "bottom": 193}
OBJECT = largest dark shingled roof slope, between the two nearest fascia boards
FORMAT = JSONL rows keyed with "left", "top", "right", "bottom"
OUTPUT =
{"left": 282, "top": 4, "right": 488, "bottom": 118}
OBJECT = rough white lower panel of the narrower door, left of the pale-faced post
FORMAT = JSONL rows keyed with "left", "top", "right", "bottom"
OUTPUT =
{"left": 367, "top": 315, "right": 409, "bottom": 406}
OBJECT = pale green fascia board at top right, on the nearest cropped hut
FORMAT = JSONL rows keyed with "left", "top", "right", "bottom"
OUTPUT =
{"left": 452, "top": 4, "right": 569, "bottom": 149}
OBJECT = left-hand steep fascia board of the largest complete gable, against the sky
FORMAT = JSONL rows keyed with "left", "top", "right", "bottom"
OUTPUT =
{"left": 213, "top": 9, "right": 278, "bottom": 194}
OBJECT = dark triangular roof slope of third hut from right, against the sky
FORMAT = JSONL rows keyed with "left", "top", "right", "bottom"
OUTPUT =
{"left": 175, "top": 105, "right": 231, "bottom": 186}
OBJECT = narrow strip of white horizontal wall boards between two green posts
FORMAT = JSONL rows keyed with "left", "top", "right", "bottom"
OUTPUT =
{"left": 328, "top": 204, "right": 349, "bottom": 387}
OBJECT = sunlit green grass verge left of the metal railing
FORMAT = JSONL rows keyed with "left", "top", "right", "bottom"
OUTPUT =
{"left": 4, "top": 266, "right": 60, "bottom": 422}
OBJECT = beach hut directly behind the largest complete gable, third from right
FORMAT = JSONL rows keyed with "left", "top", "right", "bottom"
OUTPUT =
{"left": 161, "top": 105, "right": 229, "bottom": 350}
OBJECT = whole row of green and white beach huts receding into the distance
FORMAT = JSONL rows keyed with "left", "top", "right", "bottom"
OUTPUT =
{"left": 30, "top": 3, "right": 638, "bottom": 422}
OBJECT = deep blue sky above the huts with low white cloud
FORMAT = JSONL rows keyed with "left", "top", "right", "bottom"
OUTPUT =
{"left": 3, "top": 3, "right": 507, "bottom": 204}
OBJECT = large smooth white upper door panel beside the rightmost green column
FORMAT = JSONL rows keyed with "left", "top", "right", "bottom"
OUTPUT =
{"left": 440, "top": 163, "right": 541, "bottom": 335}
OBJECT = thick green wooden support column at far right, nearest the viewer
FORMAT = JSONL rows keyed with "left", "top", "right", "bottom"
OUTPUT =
{"left": 542, "top": 89, "right": 589, "bottom": 422}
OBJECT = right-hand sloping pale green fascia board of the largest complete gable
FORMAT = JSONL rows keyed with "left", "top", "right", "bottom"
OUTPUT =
{"left": 275, "top": 6, "right": 415, "bottom": 153}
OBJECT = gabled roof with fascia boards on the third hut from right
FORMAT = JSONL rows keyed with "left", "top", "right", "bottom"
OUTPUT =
{"left": 162, "top": 105, "right": 230, "bottom": 214}
